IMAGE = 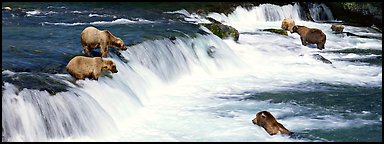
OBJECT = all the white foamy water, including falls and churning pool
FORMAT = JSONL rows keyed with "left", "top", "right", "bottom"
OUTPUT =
{"left": 2, "top": 4, "right": 382, "bottom": 142}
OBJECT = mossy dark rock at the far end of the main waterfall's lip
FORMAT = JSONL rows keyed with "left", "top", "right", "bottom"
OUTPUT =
{"left": 200, "top": 18, "right": 239, "bottom": 41}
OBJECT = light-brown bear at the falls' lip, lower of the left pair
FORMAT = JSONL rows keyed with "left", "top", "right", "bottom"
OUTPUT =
{"left": 66, "top": 56, "right": 117, "bottom": 80}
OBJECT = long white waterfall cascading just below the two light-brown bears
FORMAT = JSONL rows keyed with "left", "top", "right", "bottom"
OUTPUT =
{"left": 2, "top": 34, "right": 241, "bottom": 141}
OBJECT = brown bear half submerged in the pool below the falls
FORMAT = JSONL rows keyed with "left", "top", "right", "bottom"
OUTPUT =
{"left": 252, "top": 111, "right": 293, "bottom": 135}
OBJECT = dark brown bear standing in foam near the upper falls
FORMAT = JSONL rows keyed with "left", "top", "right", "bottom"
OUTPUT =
{"left": 292, "top": 25, "right": 327, "bottom": 50}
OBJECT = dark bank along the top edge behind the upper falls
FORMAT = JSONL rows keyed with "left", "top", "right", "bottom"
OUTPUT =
{"left": 183, "top": 2, "right": 383, "bottom": 31}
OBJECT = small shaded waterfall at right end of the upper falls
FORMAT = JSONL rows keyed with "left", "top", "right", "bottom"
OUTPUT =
{"left": 308, "top": 3, "right": 334, "bottom": 21}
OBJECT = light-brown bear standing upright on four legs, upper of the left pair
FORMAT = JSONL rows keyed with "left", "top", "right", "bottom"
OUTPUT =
{"left": 81, "top": 26, "right": 127, "bottom": 58}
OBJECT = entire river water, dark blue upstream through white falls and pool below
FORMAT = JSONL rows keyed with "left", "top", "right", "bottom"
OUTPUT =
{"left": 2, "top": 3, "right": 382, "bottom": 142}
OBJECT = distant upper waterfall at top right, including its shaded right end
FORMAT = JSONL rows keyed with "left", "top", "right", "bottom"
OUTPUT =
{"left": 207, "top": 3, "right": 334, "bottom": 32}
